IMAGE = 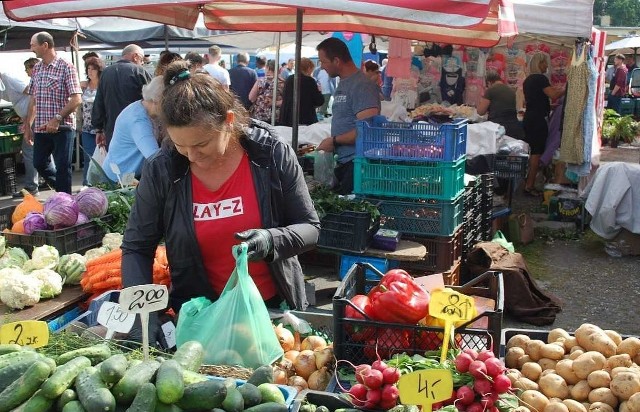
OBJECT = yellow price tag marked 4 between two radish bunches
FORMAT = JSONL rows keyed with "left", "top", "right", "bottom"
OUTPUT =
{"left": 398, "top": 369, "right": 453, "bottom": 411}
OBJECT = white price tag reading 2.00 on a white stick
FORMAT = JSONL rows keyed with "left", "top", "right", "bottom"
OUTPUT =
{"left": 118, "top": 284, "right": 169, "bottom": 360}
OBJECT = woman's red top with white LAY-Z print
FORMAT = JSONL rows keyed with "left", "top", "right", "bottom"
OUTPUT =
{"left": 191, "top": 153, "right": 276, "bottom": 300}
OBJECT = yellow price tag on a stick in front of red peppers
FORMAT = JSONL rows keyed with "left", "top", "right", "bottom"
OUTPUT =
{"left": 429, "top": 289, "right": 475, "bottom": 363}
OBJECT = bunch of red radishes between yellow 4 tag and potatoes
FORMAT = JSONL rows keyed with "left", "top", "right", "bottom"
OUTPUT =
{"left": 442, "top": 349, "right": 511, "bottom": 412}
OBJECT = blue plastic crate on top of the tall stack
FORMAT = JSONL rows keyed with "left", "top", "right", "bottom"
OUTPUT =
{"left": 356, "top": 116, "right": 467, "bottom": 162}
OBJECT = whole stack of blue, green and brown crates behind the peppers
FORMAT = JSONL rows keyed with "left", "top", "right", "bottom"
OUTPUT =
{"left": 354, "top": 116, "right": 467, "bottom": 284}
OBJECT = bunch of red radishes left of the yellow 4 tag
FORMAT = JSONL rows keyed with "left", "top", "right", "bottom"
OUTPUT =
{"left": 348, "top": 359, "right": 400, "bottom": 410}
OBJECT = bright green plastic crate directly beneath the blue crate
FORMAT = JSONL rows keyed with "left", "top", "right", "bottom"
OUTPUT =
{"left": 353, "top": 157, "right": 465, "bottom": 200}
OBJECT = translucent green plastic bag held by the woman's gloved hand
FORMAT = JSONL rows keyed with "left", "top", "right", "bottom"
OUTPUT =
{"left": 176, "top": 243, "right": 284, "bottom": 368}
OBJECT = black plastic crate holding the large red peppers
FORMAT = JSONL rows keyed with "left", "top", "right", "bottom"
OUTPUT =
{"left": 333, "top": 264, "right": 504, "bottom": 364}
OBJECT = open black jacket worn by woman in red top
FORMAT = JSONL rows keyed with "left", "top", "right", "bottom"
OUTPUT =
{"left": 122, "top": 121, "right": 320, "bottom": 313}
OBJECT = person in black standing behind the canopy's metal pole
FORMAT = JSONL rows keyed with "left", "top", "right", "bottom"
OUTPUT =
{"left": 279, "top": 57, "right": 324, "bottom": 126}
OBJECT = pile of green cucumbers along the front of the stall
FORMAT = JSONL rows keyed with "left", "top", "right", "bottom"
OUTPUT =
{"left": 0, "top": 341, "right": 288, "bottom": 412}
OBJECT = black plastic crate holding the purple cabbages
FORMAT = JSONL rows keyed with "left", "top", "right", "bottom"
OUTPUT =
{"left": 0, "top": 206, "right": 111, "bottom": 256}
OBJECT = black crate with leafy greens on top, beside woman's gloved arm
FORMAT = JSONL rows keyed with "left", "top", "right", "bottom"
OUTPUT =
{"left": 318, "top": 211, "right": 380, "bottom": 252}
